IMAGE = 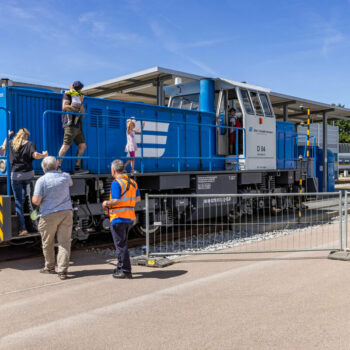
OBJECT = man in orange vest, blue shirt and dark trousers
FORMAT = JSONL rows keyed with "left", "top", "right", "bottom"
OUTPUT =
{"left": 102, "top": 159, "right": 141, "bottom": 278}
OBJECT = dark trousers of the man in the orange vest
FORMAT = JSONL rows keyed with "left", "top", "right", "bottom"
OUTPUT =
{"left": 111, "top": 222, "right": 132, "bottom": 273}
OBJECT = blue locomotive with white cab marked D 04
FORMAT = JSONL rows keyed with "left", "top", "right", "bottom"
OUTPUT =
{"left": 0, "top": 79, "right": 328, "bottom": 241}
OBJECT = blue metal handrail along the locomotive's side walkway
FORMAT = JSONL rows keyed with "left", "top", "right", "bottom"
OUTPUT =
{"left": 42, "top": 110, "right": 246, "bottom": 174}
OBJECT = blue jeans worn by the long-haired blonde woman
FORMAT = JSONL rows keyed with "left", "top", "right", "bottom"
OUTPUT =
{"left": 11, "top": 179, "right": 33, "bottom": 231}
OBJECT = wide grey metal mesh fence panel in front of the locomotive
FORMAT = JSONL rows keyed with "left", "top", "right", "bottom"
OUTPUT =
{"left": 145, "top": 192, "right": 348, "bottom": 256}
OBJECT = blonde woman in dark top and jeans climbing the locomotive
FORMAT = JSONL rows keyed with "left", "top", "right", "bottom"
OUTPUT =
{"left": 9, "top": 128, "right": 47, "bottom": 236}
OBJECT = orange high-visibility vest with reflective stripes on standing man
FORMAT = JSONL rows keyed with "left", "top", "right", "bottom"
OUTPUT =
{"left": 108, "top": 175, "right": 137, "bottom": 222}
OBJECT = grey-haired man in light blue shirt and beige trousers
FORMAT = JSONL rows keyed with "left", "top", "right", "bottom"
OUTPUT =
{"left": 32, "top": 157, "right": 73, "bottom": 280}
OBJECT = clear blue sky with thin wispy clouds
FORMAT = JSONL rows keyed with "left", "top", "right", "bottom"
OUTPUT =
{"left": 0, "top": 0, "right": 350, "bottom": 107}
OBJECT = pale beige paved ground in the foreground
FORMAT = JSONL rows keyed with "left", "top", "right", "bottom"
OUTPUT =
{"left": 0, "top": 243, "right": 350, "bottom": 350}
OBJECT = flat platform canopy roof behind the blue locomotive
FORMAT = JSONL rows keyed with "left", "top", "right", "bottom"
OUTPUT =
{"left": 83, "top": 67, "right": 350, "bottom": 123}
